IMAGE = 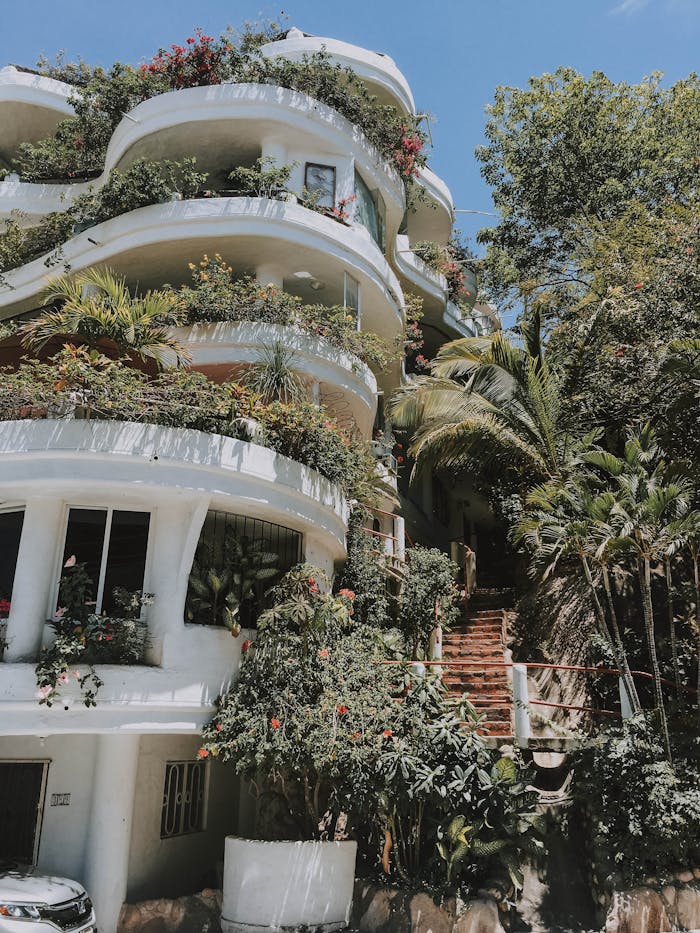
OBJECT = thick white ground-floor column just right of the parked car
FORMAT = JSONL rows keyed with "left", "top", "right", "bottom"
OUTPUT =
{"left": 83, "top": 734, "right": 139, "bottom": 933}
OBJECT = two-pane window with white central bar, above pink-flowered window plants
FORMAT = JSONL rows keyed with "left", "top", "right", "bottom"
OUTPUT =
{"left": 63, "top": 508, "right": 150, "bottom": 613}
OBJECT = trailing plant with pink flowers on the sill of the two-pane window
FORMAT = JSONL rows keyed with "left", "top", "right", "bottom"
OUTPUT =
{"left": 36, "top": 556, "right": 153, "bottom": 707}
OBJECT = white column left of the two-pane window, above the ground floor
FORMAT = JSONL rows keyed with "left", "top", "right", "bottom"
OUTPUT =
{"left": 5, "top": 497, "right": 63, "bottom": 661}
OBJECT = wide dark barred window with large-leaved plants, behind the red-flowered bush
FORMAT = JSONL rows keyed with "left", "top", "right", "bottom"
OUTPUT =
{"left": 185, "top": 510, "right": 302, "bottom": 628}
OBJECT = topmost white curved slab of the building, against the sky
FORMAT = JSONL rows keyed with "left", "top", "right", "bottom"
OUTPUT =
{"left": 261, "top": 29, "right": 416, "bottom": 114}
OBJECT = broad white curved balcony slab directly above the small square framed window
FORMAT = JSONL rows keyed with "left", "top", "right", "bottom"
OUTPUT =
{"left": 0, "top": 82, "right": 404, "bottom": 234}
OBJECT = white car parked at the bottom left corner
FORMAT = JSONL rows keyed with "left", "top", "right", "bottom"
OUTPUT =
{"left": 0, "top": 862, "right": 95, "bottom": 933}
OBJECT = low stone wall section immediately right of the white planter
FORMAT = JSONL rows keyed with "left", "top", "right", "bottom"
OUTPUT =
{"left": 350, "top": 881, "right": 504, "bottom": 933}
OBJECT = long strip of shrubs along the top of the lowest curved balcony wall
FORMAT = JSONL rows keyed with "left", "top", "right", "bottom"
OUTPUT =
{"left": 0, "top": 346, "right": 375, "bottom": 498}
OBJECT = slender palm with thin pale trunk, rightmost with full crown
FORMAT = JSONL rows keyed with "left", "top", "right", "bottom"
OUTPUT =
{"left": 584, "top": 426, "right": 690, "bottom": 760}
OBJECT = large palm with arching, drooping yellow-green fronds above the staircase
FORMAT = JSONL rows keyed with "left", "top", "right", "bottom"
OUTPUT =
{"left": 389, "top": 319, "right": 573, "bottom": 485}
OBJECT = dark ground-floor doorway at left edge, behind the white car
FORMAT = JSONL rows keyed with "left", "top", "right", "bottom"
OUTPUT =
{"left": 0, "top": 761, "right": 48, "bottom": 865}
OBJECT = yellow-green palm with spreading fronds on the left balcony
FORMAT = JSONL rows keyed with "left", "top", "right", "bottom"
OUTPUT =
{"left": 21, "top": 269, "right": 189, "bottom": 366}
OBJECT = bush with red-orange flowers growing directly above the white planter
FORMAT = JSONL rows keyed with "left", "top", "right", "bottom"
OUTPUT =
{"left": 199, "top": 565, "right": 396, "bottom": 839}
